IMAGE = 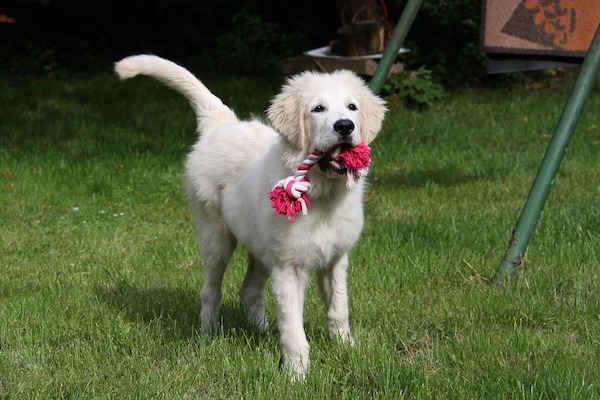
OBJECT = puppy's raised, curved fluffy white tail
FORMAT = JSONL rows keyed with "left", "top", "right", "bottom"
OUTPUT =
{"left": 115, "top": 54, "right": 237, "bottom": 123}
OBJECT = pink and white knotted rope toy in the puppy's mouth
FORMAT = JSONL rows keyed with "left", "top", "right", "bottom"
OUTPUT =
{"left": 268, "top": 142, "right": 371, "bottom": 222}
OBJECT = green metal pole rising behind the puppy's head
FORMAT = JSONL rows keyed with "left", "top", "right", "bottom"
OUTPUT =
{"left": 369, "top": 0, "right": 423, "bottom": 94}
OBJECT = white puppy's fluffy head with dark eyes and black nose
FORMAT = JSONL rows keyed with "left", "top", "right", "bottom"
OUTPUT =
{"left": 267, "top": 71, "right": 386, "bottom": 160}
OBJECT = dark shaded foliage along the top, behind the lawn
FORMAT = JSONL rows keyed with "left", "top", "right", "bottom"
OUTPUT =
{"left": 0, "top": 0, "right": 484, "bottom": 86}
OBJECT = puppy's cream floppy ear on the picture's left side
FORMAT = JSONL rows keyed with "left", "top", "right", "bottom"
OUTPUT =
{"left": 267, "top": 81, "right": 307, "bottom": 150}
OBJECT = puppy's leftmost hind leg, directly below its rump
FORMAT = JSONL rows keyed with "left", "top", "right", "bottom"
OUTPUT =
{"left": 200, "top": 214, "right": 236, "bottom": 332}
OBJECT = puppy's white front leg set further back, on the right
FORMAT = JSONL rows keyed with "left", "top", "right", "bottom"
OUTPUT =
{"left": 318, "top": 254, "right": 354, "bottom": 345}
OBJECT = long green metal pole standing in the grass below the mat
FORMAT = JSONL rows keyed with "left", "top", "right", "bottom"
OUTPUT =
{"left": 493, "top": 26, "right": 600, "bottom": 285}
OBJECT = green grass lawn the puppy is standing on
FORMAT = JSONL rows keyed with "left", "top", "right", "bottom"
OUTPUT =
{"left": 0, "top": 70, "right": 600, "bottom": 399}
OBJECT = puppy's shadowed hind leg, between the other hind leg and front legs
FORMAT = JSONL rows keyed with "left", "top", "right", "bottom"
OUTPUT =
{"left": 240, "top": 254, "right": 269, "bottom": 332}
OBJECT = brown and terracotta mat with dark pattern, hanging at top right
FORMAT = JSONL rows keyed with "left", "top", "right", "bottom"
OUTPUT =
{"left": 481, "top": 0, "right": 600, "bottom": 57}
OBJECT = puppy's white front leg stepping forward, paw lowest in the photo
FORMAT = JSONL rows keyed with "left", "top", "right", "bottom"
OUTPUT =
{"left": 272, "top": 266, "right": 309, "bottom": 377}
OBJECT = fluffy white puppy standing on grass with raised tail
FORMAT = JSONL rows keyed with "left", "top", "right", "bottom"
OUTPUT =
{"left": 115, "top": 55, "right": 386, "bottom": 376}
